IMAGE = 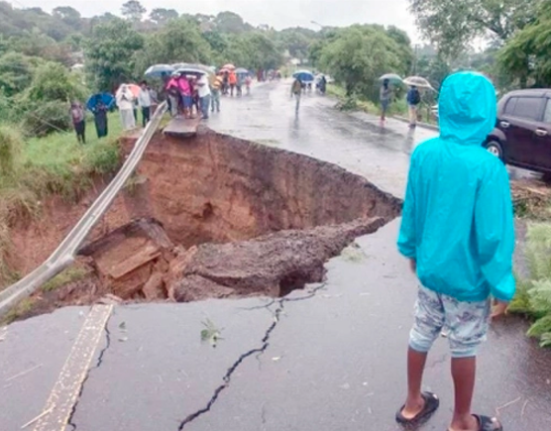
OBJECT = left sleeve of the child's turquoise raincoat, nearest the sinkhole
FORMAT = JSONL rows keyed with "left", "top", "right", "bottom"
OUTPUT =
{"left": 398, "top": 152, "right": 417, "bottom": 259}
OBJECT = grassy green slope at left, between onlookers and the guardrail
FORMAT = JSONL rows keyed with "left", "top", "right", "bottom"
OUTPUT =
{"left": 0, "top": 113, "right": 122, "bottom": 287}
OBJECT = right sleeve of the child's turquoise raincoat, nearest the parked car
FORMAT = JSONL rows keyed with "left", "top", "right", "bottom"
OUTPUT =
{"left": 474, "top": 164, "right": 516, "bottom": 302}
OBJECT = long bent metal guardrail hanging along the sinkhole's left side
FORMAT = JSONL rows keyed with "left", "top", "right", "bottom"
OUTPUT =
{"left": 0, "top": 102, "right": 167, "bottom": 317}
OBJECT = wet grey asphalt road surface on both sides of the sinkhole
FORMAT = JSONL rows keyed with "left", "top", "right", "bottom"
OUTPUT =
{"left": 0, "top": 83, "right": 551, "bottom": 431}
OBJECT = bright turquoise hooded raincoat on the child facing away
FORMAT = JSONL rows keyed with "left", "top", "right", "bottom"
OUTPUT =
{"left": 398, "top": 72, "right": 515, "bottom": 301}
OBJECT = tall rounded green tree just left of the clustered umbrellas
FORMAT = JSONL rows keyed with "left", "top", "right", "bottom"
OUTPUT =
{"left": 85, "top": 19, "right": 144, "bottom": 91}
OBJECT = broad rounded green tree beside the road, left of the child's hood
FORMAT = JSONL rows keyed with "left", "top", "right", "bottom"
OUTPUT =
{"left": 320, "top": 25, "right": 407, "bottom": 98}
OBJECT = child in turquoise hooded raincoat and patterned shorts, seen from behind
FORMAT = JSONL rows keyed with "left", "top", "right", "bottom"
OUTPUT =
{"left": 396, "top": 72, "right": 515, "bottom": 431}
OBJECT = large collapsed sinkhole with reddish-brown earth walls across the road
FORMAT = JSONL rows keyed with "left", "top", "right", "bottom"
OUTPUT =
{"left": 22, "top": 130, "right": 401, "bottom": 314}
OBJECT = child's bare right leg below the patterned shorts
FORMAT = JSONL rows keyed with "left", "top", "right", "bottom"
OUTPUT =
{"left": 450, "top": 357, "right": 478, "bottom": 431}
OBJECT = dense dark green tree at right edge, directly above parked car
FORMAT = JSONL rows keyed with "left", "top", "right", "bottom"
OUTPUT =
{"left": 498, "top": 2, "right": 551, "bottom": 87}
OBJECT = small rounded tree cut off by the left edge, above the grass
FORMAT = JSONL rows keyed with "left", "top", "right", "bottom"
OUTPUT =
{"left": 0, "top": 52, "right": 33, "bottom": 97}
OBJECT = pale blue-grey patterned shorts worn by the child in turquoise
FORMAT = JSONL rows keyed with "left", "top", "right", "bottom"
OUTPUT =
{"left": 409, "top": 287, "right": 490, "bottom": 358}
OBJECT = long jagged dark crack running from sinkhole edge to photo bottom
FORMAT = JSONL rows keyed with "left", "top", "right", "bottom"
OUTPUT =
{"left": 178, "top": 283, "right": 326, "bottom": 431}
